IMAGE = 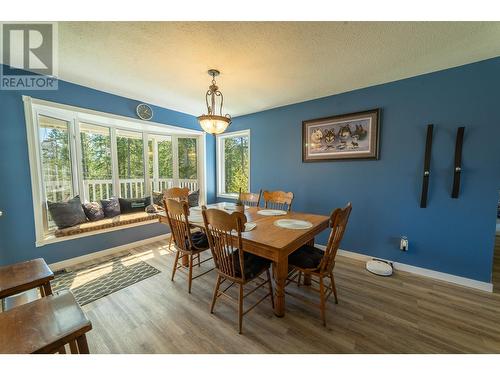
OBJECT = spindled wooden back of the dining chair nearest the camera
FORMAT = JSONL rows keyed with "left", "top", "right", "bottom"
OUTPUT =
{"left": 202, "top": 207, "right": 247, "bottom": 281}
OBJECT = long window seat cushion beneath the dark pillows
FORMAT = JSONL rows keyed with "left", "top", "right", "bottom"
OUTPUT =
{"left": 54, "top": 212, "right": 158, "bottom": 237}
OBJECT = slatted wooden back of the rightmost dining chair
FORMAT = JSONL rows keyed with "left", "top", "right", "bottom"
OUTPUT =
{"left": 319, "top": 202, "right": 352, "bottom": 273}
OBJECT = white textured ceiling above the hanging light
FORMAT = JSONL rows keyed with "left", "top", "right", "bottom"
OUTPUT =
{"left": 52, "top": 22, "right": 500, "bottom": 116}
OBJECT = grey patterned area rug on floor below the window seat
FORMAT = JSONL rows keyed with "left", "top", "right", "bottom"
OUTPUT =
{"left": 51, "top": 254, "right": 160, "bottom": 306}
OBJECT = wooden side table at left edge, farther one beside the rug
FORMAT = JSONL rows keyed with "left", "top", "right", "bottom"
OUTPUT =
{"left": 0, "top": 258, "right": 54, "bottom": 312}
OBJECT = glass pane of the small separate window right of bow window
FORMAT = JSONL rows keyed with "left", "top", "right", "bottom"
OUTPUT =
{"left": 223, "top": 137, "right": 250, "bottom": 194}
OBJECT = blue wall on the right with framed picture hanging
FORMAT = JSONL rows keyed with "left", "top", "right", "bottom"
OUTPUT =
{"left": 226, "top": 58, "right": 500, "bottom": 282}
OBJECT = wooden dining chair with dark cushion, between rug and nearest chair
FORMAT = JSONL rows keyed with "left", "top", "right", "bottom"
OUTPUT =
{"left": 164, "top": 199, "right": 214, "bottom": 293}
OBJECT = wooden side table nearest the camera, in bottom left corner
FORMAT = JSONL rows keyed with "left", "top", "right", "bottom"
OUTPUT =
{"left": 0, "top": 292, "right": 92, "bottom": 354}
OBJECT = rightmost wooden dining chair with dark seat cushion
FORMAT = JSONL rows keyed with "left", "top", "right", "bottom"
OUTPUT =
{"left": 285, "top": 202, "right": 352, "bottom": 326}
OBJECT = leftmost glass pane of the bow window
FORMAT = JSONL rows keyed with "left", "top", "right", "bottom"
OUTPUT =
{"left": 38, "top": 116, "right": 74, "bottom": 229}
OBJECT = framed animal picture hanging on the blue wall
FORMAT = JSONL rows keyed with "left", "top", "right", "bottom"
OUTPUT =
{"left": 302, "top": 108, "right": 380, "bottom": 162}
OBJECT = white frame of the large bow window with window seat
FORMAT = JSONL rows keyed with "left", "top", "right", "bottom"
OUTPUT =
{"left": 23, "top": 96, "right": 207, "bottom": 247}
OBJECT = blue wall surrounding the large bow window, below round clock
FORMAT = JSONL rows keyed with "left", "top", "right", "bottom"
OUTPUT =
{"left": 0, "top": 69, "right": 215, "bottom": 265}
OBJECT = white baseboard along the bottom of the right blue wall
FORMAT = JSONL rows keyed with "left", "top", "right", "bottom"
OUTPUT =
{"left": 316, "top": 245, "right": 493, "bottom": 292}
